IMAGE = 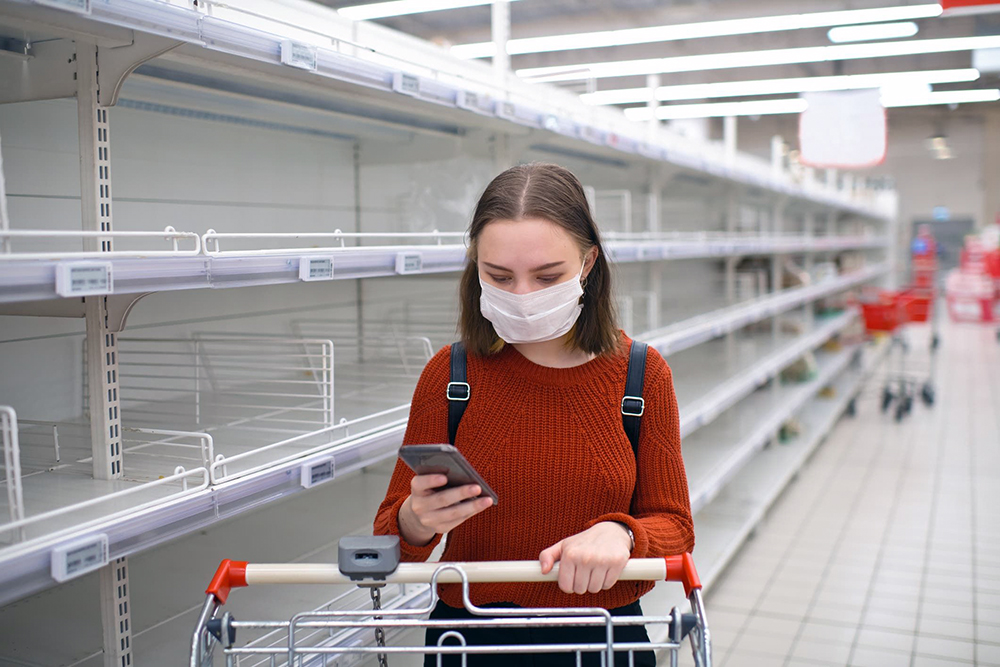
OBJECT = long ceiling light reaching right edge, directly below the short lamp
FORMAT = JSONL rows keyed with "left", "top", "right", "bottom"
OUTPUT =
{"left": 517, "top": 35, "right": 1000, "bottom": 82}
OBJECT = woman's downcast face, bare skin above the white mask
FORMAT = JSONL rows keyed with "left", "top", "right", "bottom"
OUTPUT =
{"left": 477, "top": 218, "right": 597, "bottom": 294}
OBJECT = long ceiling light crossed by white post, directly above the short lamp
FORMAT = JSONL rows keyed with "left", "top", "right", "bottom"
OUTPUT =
{"left": 451, "top": 3, "right": 941, "bottom": 58}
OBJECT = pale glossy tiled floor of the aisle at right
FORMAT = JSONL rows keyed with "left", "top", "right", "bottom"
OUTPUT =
{"left": 707, "top": 325, "right": 1000, "bottom": 667}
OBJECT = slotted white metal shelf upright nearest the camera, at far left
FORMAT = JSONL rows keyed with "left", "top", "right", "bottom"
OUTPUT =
{"left": 76, "top": 43, "right": 132, "bottom": 667}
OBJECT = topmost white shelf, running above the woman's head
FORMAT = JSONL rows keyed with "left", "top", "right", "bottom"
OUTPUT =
{"left": 0, "top": 0, "right": 894, "bottom": 219}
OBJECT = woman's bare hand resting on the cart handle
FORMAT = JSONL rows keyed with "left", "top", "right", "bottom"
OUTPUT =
{"left": 538, "top": 521, "right": 631, "bottom": 594}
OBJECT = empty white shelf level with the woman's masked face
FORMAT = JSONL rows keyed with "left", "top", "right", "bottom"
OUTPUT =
{"left": 0, "top": 233, "right": 888, "bottom": 303}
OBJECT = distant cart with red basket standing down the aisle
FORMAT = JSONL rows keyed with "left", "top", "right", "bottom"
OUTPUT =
{"left": 861, "top": 286, "right": 940, "bottom": 421}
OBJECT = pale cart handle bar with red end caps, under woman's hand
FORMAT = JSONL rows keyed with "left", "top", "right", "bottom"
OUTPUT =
{"left": 205, "top": 553, "right": 701, "bottom": 604}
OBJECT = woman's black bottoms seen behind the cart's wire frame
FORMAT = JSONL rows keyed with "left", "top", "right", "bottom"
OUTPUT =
{"left": 424, "top": 600, "right": 656, "bottom": 667}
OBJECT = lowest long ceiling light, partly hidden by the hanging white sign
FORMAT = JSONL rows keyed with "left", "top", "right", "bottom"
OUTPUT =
{"left": 625, "top": 88, "right": 1000, "bottom": 121}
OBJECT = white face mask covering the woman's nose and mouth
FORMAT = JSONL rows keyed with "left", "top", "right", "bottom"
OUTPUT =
{"left": 479, "top": 266, "right": 583, "bottom": 343}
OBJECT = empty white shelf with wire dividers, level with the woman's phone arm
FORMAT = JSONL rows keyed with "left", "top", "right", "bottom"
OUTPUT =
{"left": 0, "top": 284, "right": 868, "bottom": 601}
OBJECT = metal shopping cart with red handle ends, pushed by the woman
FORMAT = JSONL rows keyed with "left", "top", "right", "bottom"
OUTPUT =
{"left": 189, "top": 538, "right": 712, "bottom": 667}
